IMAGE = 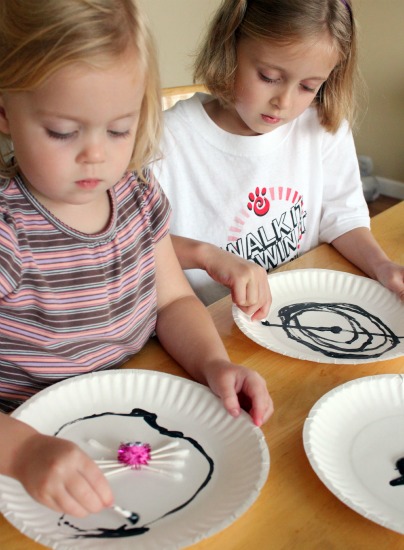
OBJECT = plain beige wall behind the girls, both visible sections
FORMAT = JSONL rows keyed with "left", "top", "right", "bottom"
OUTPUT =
{"left": 140, "top": 0, "right": 404, "bottom": 182}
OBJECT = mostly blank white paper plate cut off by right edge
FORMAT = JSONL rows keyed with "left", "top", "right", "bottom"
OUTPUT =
{"left": 303, "top": 374, "right": 404, "bottom": 534}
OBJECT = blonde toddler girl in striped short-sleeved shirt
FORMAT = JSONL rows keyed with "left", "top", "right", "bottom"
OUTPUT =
{"left": 0, "top": 0, "right": 272, "bottom": 516}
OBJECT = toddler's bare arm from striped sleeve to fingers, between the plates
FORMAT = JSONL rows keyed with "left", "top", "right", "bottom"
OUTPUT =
{"left": 156, "top": 238, "right": 273, "bottom": 425}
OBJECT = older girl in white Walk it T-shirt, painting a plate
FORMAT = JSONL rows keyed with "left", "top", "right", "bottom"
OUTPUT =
{"left": 158, "top": 0, "right": 404, "bottom": 319}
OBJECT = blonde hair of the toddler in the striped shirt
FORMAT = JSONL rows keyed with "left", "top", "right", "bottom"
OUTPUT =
{"left": 0, "top": 0, "right": 161, "bottom": 177}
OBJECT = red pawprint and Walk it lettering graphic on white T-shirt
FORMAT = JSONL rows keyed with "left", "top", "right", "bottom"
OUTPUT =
{"left": 226, "top": 186, "right": 307, "bottom": 271}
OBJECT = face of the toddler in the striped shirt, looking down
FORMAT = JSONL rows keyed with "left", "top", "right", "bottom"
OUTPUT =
{"left": 0, "top": 51, "right": 145, "bottom": 213}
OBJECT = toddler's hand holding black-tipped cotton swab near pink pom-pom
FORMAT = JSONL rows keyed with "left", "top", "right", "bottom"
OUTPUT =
{"left": 14, "top": 433, "right": 113, "bottom": 517}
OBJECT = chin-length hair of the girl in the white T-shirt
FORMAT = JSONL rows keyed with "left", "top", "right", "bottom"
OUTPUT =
{"left": 194, "top": 0, "right": 364, "bottom": 133}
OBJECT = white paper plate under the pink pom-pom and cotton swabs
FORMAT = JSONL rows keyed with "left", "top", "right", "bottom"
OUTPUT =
{"left": 0, "top": 370, "right": 269, "bottom": 550}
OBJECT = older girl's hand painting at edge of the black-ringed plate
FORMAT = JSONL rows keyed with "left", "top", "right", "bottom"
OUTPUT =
{"left": 206, "top": 247, "right": 272, "bottom": 321}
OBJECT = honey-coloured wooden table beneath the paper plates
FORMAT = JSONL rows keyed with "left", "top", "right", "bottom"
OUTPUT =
{"left": 0, "top": 202, "right": 404, "bottom": 550}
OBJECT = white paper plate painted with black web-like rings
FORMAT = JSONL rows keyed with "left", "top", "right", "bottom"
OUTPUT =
{"left": 233, "top": 269, "right": 404, "bottom": 364}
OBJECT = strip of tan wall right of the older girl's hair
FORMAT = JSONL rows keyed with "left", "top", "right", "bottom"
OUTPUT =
{"left": 354, "top": 0, "right": 404, "bottom": 182}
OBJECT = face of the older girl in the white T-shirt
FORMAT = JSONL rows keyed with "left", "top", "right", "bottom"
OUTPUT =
{"left": 215, "top": 35, "right": 338, "bottom": 135}
